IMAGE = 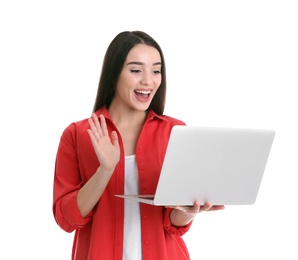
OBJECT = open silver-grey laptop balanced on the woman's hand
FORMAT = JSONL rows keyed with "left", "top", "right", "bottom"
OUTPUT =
{"left": 115, "top": 125, "right": 275, "bottom": 206}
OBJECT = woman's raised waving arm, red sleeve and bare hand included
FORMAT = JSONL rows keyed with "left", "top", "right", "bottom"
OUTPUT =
{"left": 53, "top": 116, "right": 120, "bottom": 232}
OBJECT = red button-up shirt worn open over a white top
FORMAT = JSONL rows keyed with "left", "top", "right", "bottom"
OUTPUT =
{"left": 53, "top": 108, "right": 191, "bottom": 260}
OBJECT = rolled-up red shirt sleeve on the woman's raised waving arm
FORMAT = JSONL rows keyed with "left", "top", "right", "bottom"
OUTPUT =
{"left": 53, "top": 125, "right": 92, "bottom": 232}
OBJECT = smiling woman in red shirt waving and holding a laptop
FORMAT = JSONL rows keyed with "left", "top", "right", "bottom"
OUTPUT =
{"left": 53, "top": 31, "right": 224, "bottom": 260}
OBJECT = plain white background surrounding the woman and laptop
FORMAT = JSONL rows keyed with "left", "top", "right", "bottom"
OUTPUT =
{"left": 0, "top": 0, "right": 298, "bottom": 260}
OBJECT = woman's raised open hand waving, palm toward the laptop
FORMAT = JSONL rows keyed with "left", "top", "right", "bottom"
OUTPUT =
{"left": 87, "top": 113, "right": 120, "bottom": 170}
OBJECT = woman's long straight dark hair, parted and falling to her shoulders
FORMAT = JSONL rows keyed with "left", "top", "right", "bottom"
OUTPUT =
{"left": 93, "top": 31, "right": 166, "bottom": 115}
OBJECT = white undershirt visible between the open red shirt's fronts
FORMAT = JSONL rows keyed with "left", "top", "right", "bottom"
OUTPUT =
{"left": 122, "top": 155, "right": 142, "bottom": 260}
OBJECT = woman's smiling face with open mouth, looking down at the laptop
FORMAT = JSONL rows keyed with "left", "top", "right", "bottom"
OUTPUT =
{"left": 112, "top": 44, "right": 161, "bottom": 111}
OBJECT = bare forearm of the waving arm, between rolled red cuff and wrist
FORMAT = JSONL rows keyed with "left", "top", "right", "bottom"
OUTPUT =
{"left": 77, "top": 167, "right": 113, "bottom": 218}
